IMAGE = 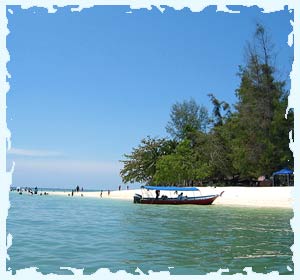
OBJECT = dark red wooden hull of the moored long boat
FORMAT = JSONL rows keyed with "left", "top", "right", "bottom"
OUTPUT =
{"left": 133, "top": 195, "right": 219, "bottom": 205}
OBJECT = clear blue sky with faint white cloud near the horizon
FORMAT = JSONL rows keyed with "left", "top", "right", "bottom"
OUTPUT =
{"left": 7, "top": 6, "right": 293, "bottom": 189}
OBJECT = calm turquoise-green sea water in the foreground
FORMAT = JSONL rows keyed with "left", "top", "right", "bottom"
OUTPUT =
{"left": 7, "top": 193, "right": 294, "bottom": 274}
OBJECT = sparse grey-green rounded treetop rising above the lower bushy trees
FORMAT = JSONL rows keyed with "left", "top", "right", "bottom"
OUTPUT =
{"left": 166, "top": 99, "right": 209, "bottom": 140}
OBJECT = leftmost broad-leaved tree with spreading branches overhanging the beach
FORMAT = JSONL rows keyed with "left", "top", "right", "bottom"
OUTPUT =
{"left": 120, "top": 136, "right": 176, "bottom": 184}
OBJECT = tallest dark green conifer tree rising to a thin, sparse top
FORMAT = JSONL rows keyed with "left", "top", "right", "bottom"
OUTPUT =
{"left": 232, "top": 25, "right": 290, "bottom": 177}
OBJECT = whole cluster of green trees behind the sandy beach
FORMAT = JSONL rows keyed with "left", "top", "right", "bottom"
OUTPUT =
{"left": 120, "top": 25, "right": 294, "bottom": 185}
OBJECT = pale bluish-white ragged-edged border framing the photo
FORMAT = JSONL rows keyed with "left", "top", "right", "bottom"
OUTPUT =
{"left": 0, "top": 0, "right": 300, "bottom": 280}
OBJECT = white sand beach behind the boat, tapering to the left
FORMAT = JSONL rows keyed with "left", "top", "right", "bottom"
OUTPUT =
{"left": 41, "top": 187, "right": 294, "bottom": 208}
